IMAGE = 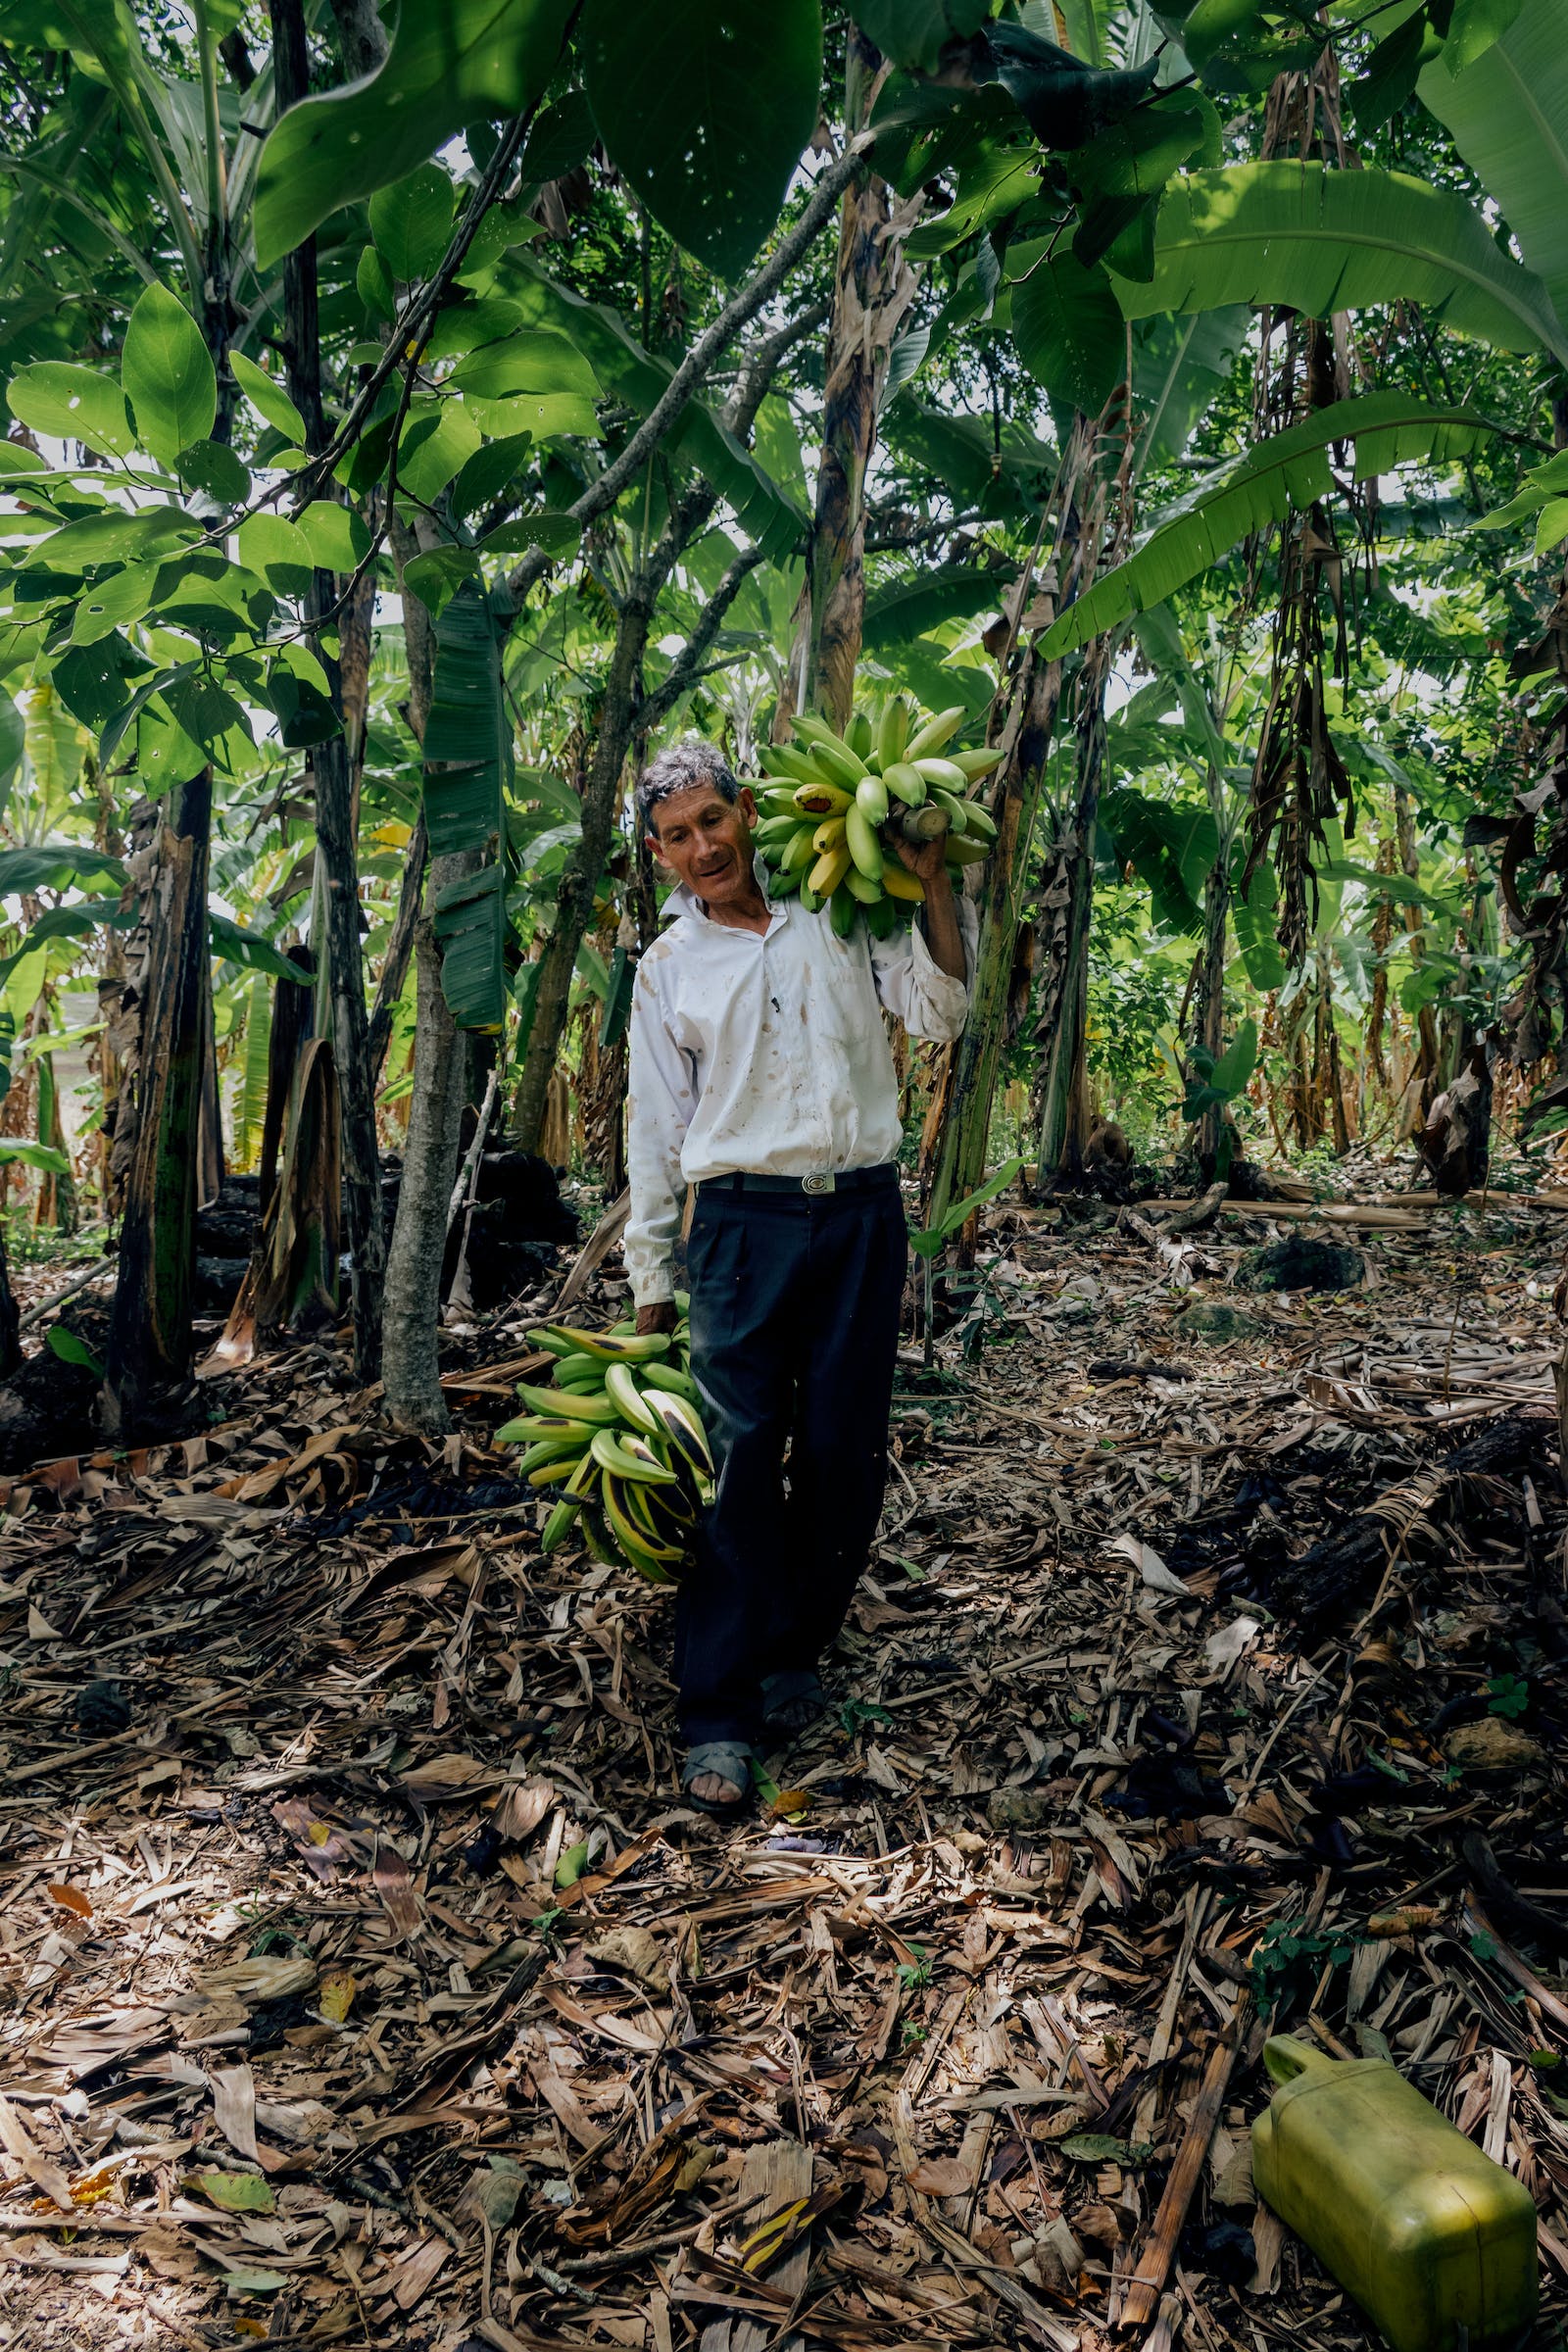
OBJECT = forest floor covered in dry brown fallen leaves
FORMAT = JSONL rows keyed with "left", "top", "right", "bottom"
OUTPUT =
{"left": 0, "top": 1176, "right": 1568, "bottom": 2352}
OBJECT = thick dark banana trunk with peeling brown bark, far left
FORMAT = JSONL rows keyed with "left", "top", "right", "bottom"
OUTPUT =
{"left": 104, "top": 769, "right": 212, "bottom": 1437}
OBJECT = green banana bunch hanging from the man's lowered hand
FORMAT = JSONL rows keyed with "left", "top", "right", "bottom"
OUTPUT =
{"left": 496, "top": 1300, "right": 712, "bottom": 1586}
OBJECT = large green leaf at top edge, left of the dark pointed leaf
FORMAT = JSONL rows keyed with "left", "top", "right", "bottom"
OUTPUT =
{"left": 254, "top": 0, "right": 571, "bottom": 269}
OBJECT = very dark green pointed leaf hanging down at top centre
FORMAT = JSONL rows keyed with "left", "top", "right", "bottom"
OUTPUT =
{"left": 578, "top": 0, "right": 823, "bottom": 277}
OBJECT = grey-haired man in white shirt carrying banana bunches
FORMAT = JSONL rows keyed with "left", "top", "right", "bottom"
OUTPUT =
{"left": 625, "top": 741, "right": 973, "bottom": 1813}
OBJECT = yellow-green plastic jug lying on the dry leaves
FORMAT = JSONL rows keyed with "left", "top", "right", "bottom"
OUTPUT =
{"left": 1253, "top": 2034, "right": 1535, "bottom": 2352}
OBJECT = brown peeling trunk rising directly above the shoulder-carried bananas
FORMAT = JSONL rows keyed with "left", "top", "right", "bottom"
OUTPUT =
{"left": 776, "top": 24, "right": 919, "bottom": 731}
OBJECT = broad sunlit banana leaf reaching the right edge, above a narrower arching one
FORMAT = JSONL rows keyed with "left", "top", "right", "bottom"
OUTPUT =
{"left": 1116, "top": 159, "right": 1568, "bottom": 363}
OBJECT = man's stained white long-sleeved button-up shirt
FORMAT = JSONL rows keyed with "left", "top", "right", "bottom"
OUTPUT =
{"left": 625, "top": 863, "right": 976, "bottom": 1305}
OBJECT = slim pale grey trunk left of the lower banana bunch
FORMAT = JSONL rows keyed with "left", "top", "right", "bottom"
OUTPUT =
{"left": 383, "top": 852, "right": 482, "bottom": 1437}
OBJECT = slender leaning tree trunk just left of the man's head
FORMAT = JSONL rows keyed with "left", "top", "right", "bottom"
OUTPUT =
{"left": 513, "top": 569, "right": 656, "bottom": 1152}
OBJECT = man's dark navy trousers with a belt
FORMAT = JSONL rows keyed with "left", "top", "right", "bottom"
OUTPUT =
{"left": 674, "top": 1169, "right": 909, "bottom": 1745}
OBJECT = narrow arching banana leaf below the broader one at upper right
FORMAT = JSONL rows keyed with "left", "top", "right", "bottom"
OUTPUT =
{"left": 1042, "top": 393, "right": 1493, "bottom": 659}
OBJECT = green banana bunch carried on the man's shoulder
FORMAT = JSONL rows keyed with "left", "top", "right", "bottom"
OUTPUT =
{"left": 757, "top": 694, "right": 1002, "bottom": 939}
